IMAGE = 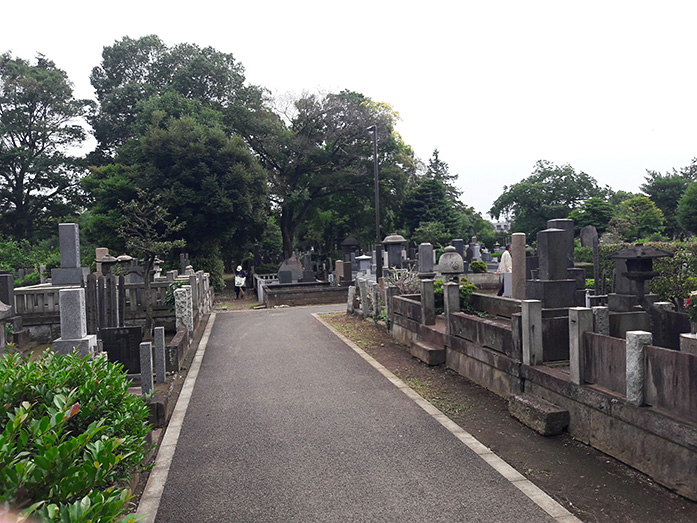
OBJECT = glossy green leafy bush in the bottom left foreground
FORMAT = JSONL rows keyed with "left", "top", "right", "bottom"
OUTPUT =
{"left": 0, "top": 352, "right": 150, "bottom": 522}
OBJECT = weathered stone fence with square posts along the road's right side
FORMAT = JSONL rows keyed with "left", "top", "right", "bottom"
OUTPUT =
{"left": 387, "top": 284, "right": 697, "bottom": 500}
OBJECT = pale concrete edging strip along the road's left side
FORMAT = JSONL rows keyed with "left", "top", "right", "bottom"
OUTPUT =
{"left": 136, "top": 312, "right": 216, "bottom": 523}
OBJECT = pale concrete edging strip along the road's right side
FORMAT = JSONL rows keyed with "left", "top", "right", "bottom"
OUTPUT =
{"left": 312, "top": 313, "right": 581, "bottom": 523}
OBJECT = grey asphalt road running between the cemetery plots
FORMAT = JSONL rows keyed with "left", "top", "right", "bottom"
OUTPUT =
{"left": 141, "top": 307, "right": 572, "bottom": 523}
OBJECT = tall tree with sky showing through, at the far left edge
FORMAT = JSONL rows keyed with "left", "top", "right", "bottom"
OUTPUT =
{"left": 0, "top": 53, "right": 92, "bottom": 239}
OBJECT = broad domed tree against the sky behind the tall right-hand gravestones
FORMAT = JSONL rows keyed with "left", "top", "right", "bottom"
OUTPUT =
{"left": 489, "top": 160, "right": 609, "bottom": 236}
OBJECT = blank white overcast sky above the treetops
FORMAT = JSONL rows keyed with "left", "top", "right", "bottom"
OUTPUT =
{"left": 0, "top": 0, "right": 697, "bottom": 217}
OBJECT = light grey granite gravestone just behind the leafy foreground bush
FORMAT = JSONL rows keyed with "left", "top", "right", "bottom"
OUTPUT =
{"left": 53, "top": 288, "right": 97, "bottom": 356}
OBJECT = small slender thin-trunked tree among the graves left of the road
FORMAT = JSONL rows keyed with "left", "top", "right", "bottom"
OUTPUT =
{"left": 118, "top": 190, "right": 186, "bottom": 340}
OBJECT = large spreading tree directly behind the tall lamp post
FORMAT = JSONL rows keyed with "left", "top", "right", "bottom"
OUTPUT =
{"left": 245, "top": 91, "right": 414, "bottom": 256}
